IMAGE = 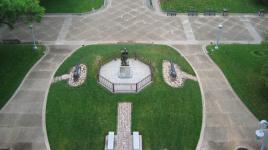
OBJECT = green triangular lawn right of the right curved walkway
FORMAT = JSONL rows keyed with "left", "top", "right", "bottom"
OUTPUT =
{"left": 208, "top": 44, "right": 268, "bottom": 119}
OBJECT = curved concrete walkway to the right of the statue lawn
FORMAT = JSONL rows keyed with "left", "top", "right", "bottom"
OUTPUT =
{"left": 172, "top": 45, "right": 258, "bottom": 150}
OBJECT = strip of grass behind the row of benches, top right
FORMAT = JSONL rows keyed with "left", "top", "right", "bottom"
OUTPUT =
{"left": 160, "top": 0, "right": 268, "bottom": 13}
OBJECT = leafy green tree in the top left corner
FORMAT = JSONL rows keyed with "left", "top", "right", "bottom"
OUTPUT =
{"left": 0, "top": 0, "right": 45, "bottom": 29}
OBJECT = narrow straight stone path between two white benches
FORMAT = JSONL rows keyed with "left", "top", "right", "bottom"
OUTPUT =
{"left": 115, "top": 103, "right": 132, "bottom": 150}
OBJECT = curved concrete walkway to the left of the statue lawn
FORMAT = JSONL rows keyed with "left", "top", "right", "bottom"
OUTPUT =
{"left": 0, "top": 45, "right": 78, "bottom": 150}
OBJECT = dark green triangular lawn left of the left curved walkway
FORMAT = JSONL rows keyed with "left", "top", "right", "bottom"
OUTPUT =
{"left": 0, "top": 44, "right": 44, "bottom": 109}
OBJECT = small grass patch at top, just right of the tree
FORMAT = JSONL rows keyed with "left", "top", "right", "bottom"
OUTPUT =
{"left": 40, "top": 0, "right": 104, "bottom": 13}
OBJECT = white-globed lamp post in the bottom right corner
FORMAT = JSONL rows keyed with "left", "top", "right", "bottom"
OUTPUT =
{"left": 255, "top": 120, "right": 268, "bottom": 150}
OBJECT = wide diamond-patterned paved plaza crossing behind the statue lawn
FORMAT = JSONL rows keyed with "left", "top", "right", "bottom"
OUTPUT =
{"left": 0, "top": 0, "right": 268, "bottom": 44}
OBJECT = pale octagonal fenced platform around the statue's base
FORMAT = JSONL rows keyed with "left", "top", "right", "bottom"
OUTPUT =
{"left": 99, "top": 59, "right": 152, "bottom": 93}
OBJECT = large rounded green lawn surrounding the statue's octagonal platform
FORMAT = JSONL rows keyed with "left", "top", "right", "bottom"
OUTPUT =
{"left": 46, "top": 45, "right": 202, "bottom": 150}
